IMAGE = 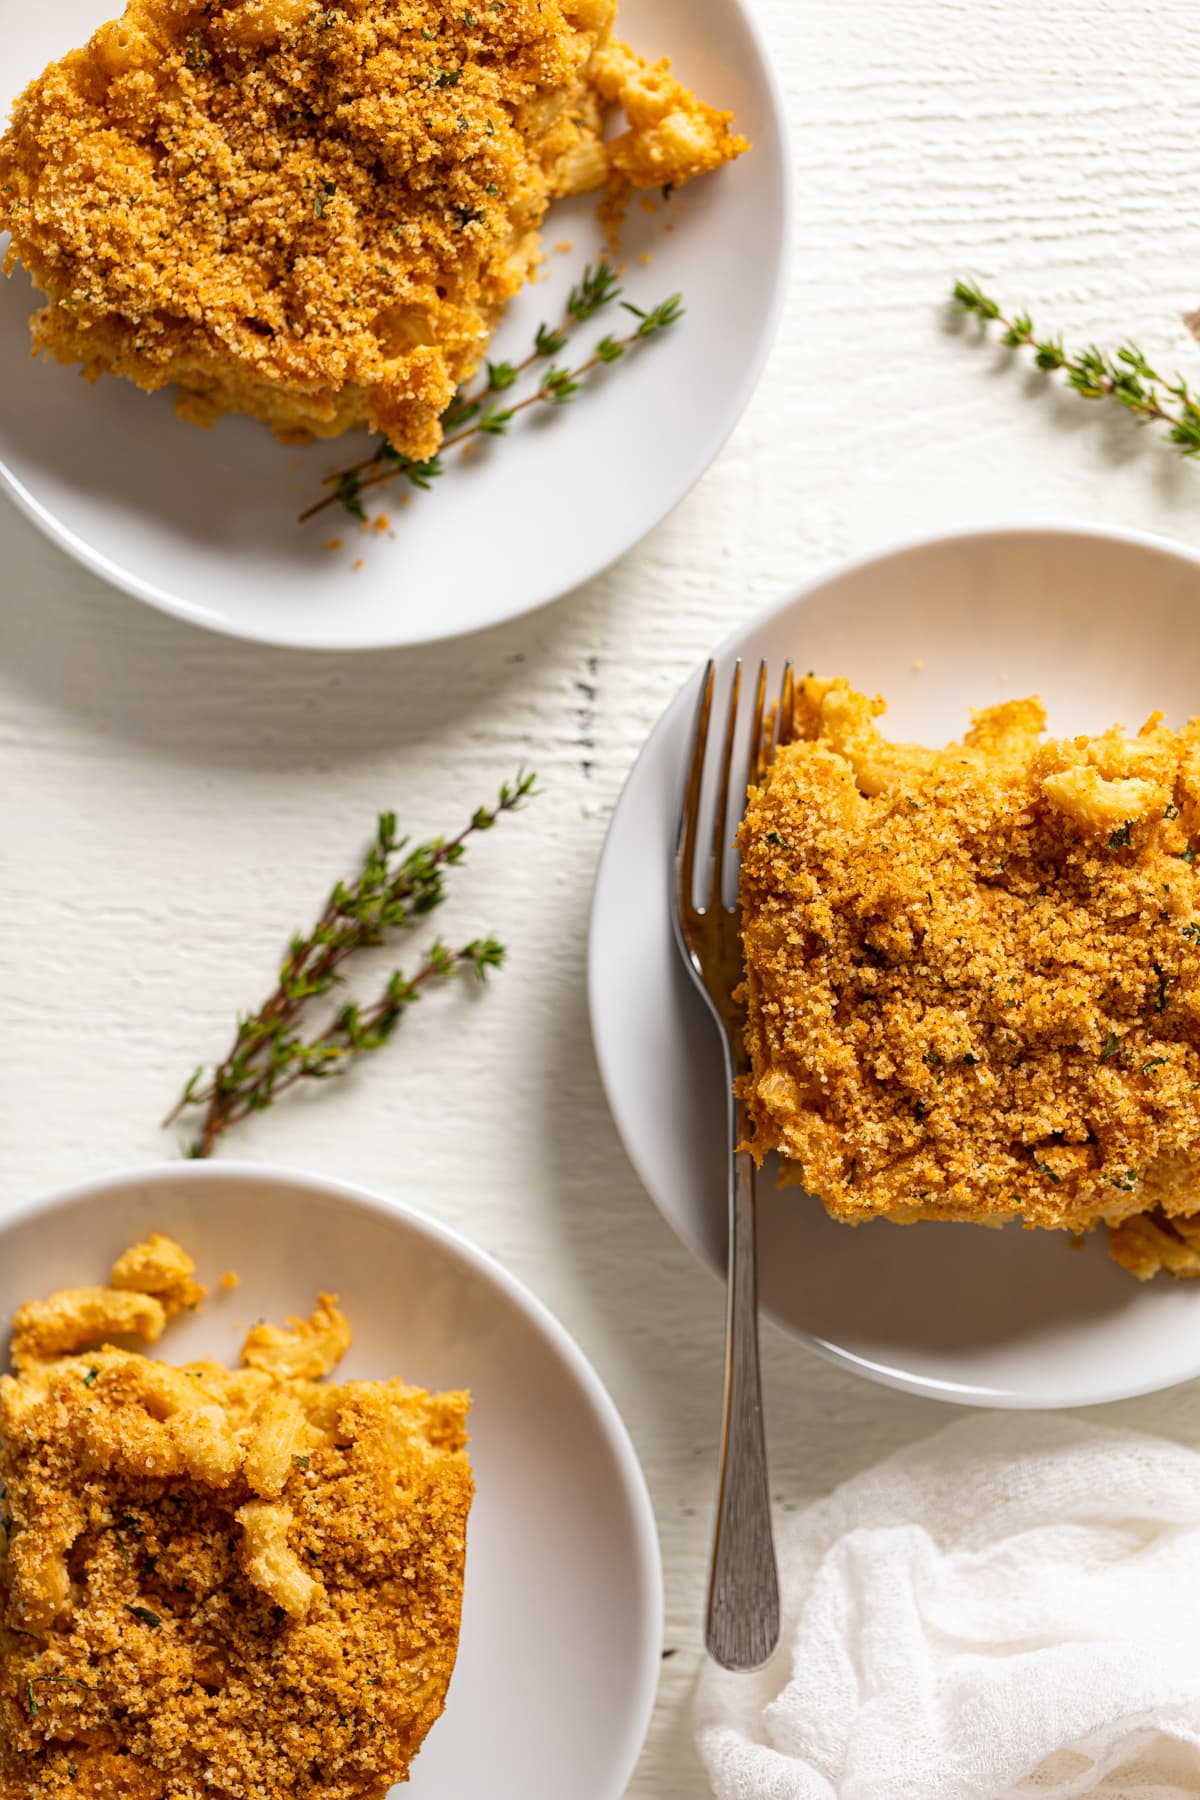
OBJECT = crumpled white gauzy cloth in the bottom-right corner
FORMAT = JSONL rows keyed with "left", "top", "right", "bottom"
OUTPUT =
{"left": 696, "top": 1413, "right": 1200, "bottom": 1800}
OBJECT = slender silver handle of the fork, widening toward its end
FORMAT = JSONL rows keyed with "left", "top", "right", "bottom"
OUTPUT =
{"left": 705, "top": 1150, "right": 779, "bottom": 1669}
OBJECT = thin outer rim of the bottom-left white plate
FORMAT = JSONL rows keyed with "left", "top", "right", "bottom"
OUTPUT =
{"left": 0, "top": 1157, "right": 666, "bottom": 1800}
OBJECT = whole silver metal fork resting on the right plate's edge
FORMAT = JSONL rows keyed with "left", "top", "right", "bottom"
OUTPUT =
{"left": 671, "top": 661, "right": 793, "bottom": 1669}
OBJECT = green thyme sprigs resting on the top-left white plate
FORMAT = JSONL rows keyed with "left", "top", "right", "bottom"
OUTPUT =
{"left": 300, "top": 263, "right": 684, "bottom": 524}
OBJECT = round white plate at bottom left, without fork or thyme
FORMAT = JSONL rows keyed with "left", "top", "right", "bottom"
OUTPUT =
{"left": 0, "top": 1163, "right": 662, "bottom": 1800}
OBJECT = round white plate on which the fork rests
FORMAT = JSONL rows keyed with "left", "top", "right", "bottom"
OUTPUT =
{"left": 588, "top": 527, "right": 1200, "bottom": 1406}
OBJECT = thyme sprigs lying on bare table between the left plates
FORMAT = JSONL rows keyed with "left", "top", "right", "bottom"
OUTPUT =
{"left": 164, "top": 770, "right": 536, "bottom": 1157}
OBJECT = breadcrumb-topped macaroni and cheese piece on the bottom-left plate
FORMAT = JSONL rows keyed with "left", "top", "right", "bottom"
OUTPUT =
{"left": 0, "top": 1237, "right": 471, "bottom": 1800}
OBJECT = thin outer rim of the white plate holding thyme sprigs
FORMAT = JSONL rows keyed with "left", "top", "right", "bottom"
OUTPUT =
{"left": 0, "top": 0, "right": 797, "bottom": 655}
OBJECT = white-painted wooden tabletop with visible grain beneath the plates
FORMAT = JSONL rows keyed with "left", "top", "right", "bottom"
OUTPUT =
{"left": 0, "top": 0, "right": 1200, "bottom": 1800}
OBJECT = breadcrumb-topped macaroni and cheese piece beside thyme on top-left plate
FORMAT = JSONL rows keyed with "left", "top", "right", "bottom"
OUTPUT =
{"left": 0, "top": 0, "right": 747, "bottom": 457}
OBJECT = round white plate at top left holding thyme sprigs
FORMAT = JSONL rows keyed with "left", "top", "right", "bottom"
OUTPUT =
{"left": 0, "top": 0, "right": 790, "bottom": 650}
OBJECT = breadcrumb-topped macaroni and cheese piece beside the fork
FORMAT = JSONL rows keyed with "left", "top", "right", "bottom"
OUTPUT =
{"left": 738, "top": 677, "right": 1200, "bottom": 1276}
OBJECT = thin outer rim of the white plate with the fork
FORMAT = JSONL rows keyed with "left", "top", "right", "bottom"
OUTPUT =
{"left": 587, "top": 518, "right": 1200, "bottom": 1411}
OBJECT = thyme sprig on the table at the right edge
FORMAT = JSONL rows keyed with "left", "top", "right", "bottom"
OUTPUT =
{"left": 954, "top": 281, "right": 1200, "bottom": 457}
